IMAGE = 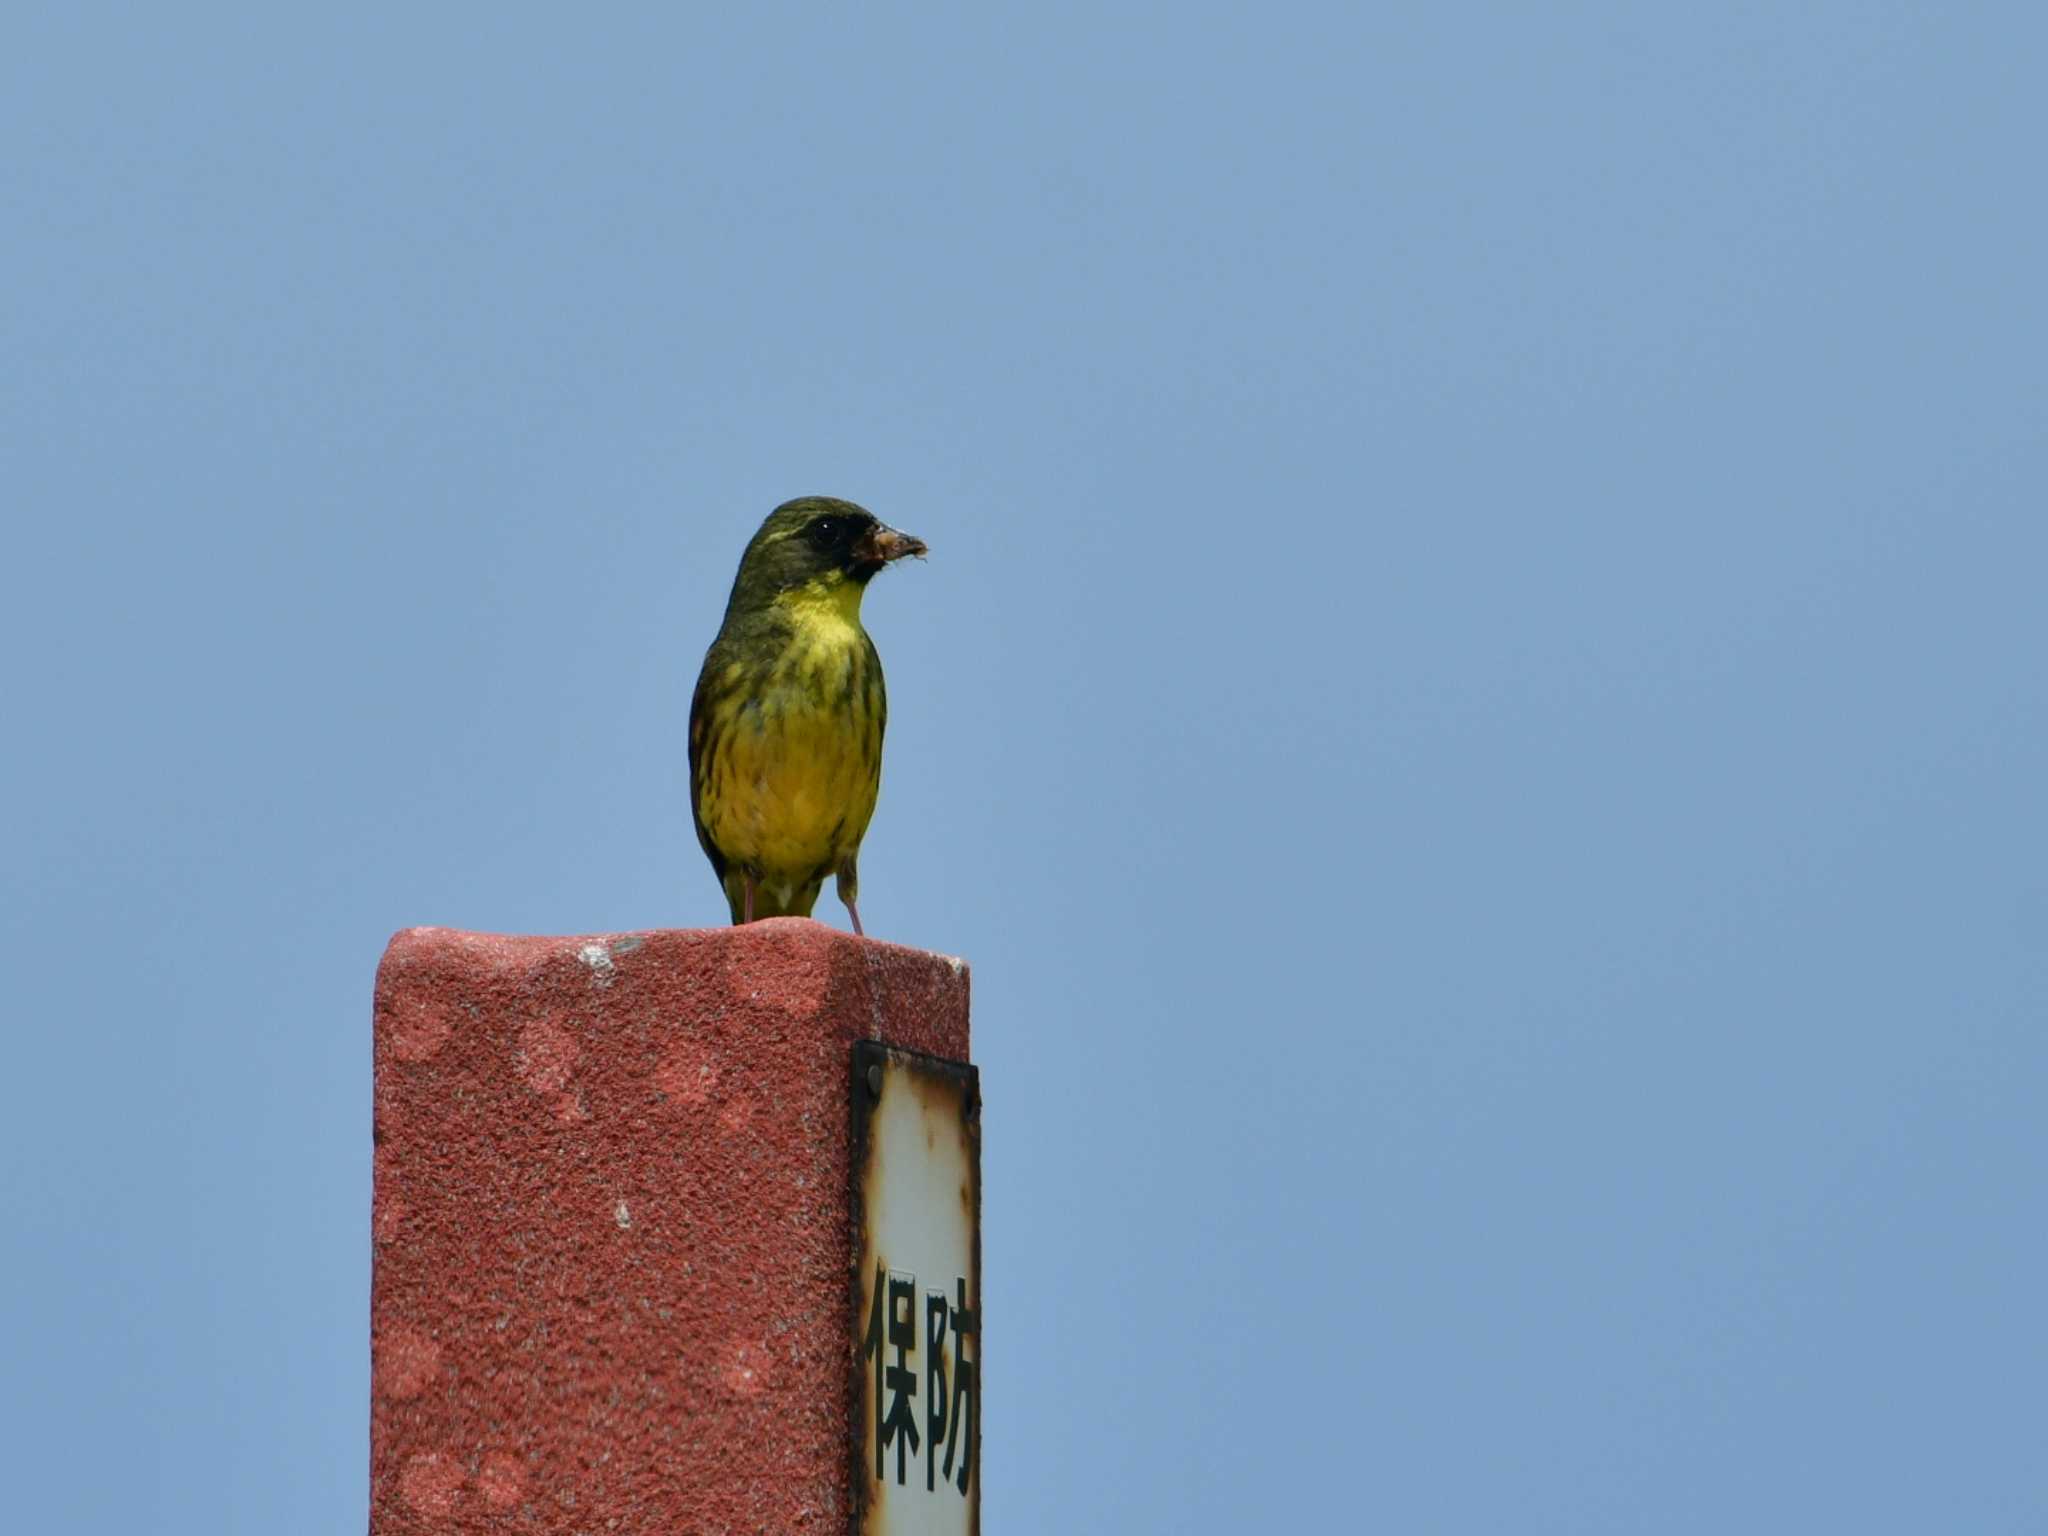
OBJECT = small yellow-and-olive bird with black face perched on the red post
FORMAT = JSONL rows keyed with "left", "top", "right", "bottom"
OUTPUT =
{"left": 690, "top": 496, "right": 926, "bottom": 934}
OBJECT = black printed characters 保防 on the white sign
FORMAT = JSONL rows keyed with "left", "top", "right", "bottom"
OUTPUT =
{"left": 860, "top": 1268, "right": 975, "bottom": 1497}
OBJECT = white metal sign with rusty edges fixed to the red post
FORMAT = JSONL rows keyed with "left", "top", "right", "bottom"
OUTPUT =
{"left": 850, "top": 1040, "right": 981, "bottom": 1536}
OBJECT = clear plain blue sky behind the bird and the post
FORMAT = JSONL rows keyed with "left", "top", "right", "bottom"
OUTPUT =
{"left": 0, "top": 4, "right": 2048, "bottom": 1536}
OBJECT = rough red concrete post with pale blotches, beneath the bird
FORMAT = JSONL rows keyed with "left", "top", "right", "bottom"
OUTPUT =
{"left": 371, "top": 918, "right": 967, "bottom": 1536}
